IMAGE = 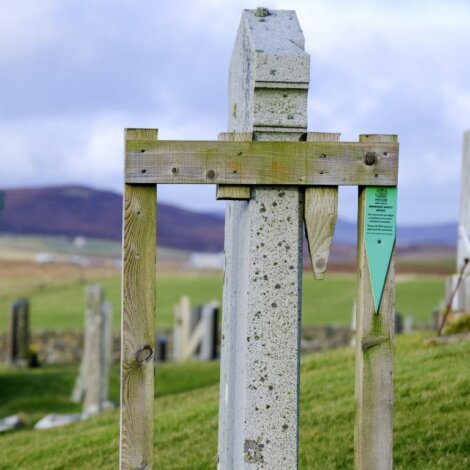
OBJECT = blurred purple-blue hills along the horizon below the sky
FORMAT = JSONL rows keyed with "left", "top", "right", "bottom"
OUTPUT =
{"left": 0, "top": 186, "right": 457, "bottom": 252}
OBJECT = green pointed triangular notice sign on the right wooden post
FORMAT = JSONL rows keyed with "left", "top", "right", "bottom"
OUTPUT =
{"left": 364, "top": 187, "right": 397, "bottom": 313}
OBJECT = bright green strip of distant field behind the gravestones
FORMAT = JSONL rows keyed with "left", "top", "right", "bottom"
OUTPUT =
{"left": 0, "top": 272, "right": 444, "bottom": 331}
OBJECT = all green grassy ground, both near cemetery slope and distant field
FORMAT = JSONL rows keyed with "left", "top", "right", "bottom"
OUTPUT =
{"left": 0, "top": 241, "right": 462, "bottom": 469}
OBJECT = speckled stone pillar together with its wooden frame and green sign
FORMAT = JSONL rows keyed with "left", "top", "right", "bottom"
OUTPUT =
{"left": 120, "top": 8, "right": 398, "bottom": 470}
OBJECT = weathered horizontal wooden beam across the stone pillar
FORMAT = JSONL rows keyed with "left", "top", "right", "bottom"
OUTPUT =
{"left": 125, "top": 134, "right": 398, "bottom": 186}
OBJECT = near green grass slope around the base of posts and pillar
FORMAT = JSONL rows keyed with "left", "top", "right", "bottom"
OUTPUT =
{"left": 0, "top": 335, "right": 470, "bottom": 470}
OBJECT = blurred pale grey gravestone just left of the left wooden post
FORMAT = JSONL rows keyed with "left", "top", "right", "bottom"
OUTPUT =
{"left": 71, "top": 284, "right": 113, "bottom": 416}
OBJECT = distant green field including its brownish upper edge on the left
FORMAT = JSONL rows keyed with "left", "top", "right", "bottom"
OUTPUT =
{"left": 0, "top": 261, "right": 444, "bottom": 331}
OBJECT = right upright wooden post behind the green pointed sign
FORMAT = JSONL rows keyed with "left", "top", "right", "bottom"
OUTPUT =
{"left": 354, "top": 135, "right": 396, "bottom": 470}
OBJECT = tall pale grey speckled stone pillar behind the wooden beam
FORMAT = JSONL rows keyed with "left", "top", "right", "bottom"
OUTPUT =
{"left": 218, "top": 8, "right": 310, "bottom": 470}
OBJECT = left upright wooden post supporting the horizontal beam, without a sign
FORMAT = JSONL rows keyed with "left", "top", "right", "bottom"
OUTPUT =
{"left": 120, "top": 129, "right": 157, "bottom": 469}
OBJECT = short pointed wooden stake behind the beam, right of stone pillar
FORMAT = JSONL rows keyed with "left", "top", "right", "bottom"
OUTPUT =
{"left": 304, "top": 132, "right": 340, "bottom": 279}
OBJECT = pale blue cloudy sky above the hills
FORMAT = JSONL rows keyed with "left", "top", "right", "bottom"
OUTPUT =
{"left": 0, "top": 0, "right": 470, "bottom": 225}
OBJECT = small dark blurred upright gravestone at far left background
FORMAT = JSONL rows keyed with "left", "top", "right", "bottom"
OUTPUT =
{"left": 8, "top": 299, "right": 29, "bottom": 367}
